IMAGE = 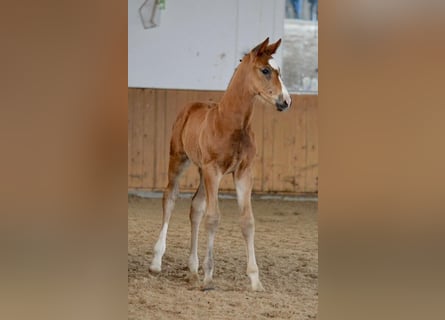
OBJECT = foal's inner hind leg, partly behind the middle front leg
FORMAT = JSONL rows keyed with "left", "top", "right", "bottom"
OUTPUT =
{"left": 189, "top": 169, "right": 206, "bottom": 281}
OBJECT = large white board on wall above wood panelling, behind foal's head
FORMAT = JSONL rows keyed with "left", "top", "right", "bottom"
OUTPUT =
{"left": 128, "top": 0, "right": 284, "bottom": 90}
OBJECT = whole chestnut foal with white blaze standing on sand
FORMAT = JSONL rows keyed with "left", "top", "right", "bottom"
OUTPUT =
{"left": 150, "top": 38, "right": 291, "bottom": 290}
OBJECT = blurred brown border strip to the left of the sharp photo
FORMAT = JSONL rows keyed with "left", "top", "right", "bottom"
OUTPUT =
{"left": 0, "top": 0, "right": 127, "bottom": 319}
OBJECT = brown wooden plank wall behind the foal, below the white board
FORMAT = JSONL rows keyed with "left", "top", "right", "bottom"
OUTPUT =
{"left": 128, "top": 88, "right": 318, "bottom": 194}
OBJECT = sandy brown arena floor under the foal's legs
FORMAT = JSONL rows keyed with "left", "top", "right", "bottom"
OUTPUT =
{"left": 128, "top": 196, "right": 318, "bottom": 320}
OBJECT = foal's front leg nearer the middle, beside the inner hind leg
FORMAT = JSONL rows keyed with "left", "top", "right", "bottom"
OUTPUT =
{"left": 202, "top": 166, "right": 222, "bottom": 290}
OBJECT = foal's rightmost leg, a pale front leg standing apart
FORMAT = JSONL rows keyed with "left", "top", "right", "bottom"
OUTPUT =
{"left": 233, "top": 168, "right": 264, "bottom": 291}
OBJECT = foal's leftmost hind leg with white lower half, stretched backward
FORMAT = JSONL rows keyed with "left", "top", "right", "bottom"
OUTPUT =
{"left": 150, "top": 153, "right": 189, "bottom": 272}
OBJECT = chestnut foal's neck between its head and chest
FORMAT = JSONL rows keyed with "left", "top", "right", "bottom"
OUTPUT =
{"left": 218, "top": 64, "right": 255, "bottom": 130}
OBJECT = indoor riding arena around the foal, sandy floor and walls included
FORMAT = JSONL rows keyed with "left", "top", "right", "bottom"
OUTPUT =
{"left": 128, "top": 0, "right": 319, "bottom": 319}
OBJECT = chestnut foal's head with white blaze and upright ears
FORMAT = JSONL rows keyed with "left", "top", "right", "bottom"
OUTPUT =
{"left": 241, "top": 38, "right": 291, "bottom": 111}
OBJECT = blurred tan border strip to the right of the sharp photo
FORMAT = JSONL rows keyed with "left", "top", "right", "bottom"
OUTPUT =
{"left": 319, "top": 1, "right": 445, "bottom": 320}
